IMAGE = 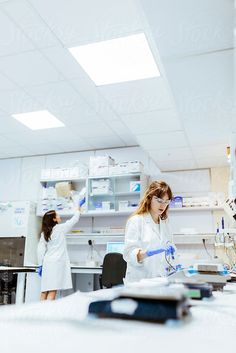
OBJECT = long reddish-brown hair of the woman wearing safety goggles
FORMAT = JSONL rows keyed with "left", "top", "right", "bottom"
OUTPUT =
{"left": 133, "top": 181, "right": 173, "bottom": 219}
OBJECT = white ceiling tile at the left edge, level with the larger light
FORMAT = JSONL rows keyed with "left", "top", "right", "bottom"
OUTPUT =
{"left": 0, "top": 51, "right": 62, "bottom": 86}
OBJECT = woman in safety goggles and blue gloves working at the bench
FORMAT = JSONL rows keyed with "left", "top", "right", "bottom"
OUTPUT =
{"left": 124, "top": 181, "right": 175, "bottom": 282}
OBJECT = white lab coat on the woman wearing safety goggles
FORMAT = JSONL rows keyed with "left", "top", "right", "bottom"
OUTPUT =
{"left": 124, "top": 213, "right": 173, "bottom": 282}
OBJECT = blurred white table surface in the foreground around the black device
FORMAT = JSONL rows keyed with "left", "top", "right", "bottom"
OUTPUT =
{"left": 0, "top": 284, "right": 236, "bottom": 353}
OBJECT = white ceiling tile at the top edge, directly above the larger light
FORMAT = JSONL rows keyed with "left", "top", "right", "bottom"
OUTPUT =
{"left": 30, "top": 0, "right": 143, "bottom": 46}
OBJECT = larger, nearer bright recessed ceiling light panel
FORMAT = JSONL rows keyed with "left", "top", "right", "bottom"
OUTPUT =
{"left": 69, "top": 33, "right": 160, "bottom": 86}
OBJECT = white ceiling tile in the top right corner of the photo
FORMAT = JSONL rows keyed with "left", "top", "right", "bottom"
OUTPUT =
{"left": 141, "top": 0, "right": 234, "bottom": 56}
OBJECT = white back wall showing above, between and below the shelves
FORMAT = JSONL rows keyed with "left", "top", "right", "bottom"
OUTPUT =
{"left": 0, "top": 147, "right": 229, "bottom": 261}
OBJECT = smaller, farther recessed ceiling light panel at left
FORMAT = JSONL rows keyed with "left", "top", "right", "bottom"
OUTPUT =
{"left": 12, "top": 110, "right": 65, "bottom": 130}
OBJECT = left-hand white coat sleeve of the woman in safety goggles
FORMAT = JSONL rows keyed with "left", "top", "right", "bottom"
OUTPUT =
{"left": 123, "top": 217, "right": 143, "bottom": 266}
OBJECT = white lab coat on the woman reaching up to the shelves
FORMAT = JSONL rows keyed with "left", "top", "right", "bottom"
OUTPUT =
{"left": 37, "top": 211, "right": 80, "bottom": 292}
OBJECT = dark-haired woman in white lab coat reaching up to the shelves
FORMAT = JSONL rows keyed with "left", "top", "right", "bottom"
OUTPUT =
{"left": 38, "top": 209, "right": 80, "bottom": 300}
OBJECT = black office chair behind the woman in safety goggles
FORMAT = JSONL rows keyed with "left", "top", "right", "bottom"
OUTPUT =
{"left": 99, "top": 252, "right": 127, "bottom": 288}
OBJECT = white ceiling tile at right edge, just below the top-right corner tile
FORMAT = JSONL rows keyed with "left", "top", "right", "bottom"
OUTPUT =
{"left": 165, "top": 50, "right": 234, "bottom": 116}
